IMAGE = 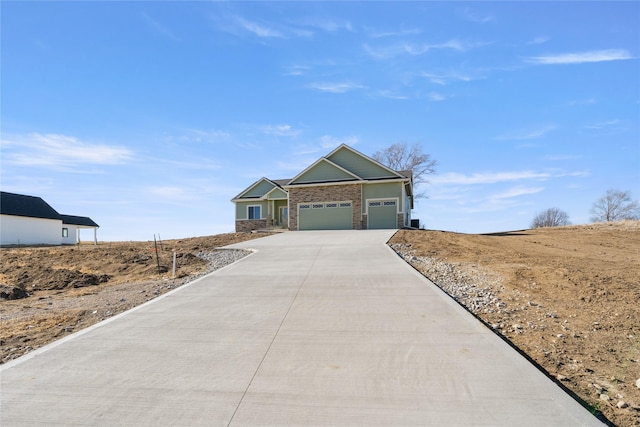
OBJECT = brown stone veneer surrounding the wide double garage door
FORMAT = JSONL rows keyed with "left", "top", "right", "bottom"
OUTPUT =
{"left": 288, "top": 184, "right": 367, "bottom": 230}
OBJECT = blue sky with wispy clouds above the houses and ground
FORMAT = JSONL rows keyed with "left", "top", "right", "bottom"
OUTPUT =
{"left": 0, "top": 1, "right": 640, "bottom": 241}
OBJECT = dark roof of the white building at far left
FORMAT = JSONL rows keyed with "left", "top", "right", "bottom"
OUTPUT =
{"left": 0, "top": 191, "right": 99, "bottom": 227}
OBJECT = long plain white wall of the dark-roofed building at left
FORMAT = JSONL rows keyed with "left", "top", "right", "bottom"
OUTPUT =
{"left": 0, "top": 215, "right": 62, "bottom": 245}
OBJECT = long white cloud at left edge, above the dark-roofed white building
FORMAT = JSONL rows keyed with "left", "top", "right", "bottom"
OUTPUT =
{"left": 2, "top": 133, "right": 133, "bottom": 170}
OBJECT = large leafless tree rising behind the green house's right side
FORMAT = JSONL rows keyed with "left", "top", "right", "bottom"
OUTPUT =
{"left": 373, "top": 142, "right": 438, "bottom": 197}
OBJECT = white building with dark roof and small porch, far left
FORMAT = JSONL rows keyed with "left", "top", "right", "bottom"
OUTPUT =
{"left": 0, "top": 191, "right": 99, "bottom": 246}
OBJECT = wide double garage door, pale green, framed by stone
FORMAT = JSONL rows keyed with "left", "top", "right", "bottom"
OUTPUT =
{"left": 298, "top": 202, "right": 353, "bottom": 230}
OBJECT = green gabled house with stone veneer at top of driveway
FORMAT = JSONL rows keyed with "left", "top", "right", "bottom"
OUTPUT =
{"left": 232, "top": 144, "right": 413, "bottom": 232}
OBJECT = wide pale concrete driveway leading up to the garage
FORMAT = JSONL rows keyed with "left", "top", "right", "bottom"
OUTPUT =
{"left": 0, "top": 230, "right": 602, "bottom": 427}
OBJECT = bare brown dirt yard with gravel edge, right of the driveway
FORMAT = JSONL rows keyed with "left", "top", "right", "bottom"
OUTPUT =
{"left": 390, "top": 221, "right": 640, "bottom": 426}
